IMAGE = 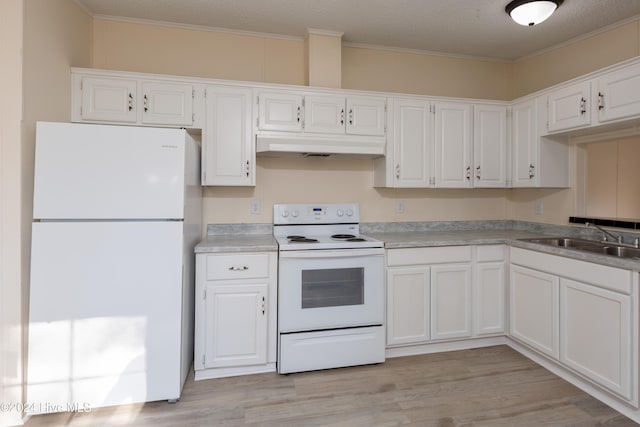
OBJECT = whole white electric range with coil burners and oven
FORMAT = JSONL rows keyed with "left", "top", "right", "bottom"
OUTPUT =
{"left": 273, "top": 203, "right": 385, "bottom": 374}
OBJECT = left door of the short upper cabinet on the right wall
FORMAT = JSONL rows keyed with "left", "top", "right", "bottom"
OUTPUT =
{"left": 547, "top": 82, "right": 591, "bottom": 132}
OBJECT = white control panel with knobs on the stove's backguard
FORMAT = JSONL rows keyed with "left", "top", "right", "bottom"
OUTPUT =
{"left": 273, "top": 203, "right": 360, "bottom": 225}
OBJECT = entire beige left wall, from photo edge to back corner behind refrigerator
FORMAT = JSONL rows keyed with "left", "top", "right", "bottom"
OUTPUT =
{"left": 0, "top": 0, "right": 92, "bottom": 422}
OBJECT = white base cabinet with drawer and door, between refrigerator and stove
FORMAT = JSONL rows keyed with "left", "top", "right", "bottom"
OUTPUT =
{"left": 194, "top": 252, "right": 277, "bottom": 380}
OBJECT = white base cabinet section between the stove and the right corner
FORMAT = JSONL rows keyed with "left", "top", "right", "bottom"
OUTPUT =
{"left": 386, "top": 245, "right": 506, "bottom": 347}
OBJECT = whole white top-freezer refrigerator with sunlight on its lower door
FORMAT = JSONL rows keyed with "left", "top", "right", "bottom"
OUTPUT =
{"left": 27, "top": 122, "right": 202, "bottom": 413}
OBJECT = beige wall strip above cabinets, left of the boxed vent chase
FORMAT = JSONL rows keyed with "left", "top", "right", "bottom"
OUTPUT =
{"left": 93, "top": 19, "right": 305, "bottom": 85}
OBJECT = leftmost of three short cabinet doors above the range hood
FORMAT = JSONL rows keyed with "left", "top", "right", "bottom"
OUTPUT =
{"left": 258, "top": 92, "right": 304, "bottom": 132}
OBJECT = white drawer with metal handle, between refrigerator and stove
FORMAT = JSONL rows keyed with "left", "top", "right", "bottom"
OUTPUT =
{"left": 206, "top": 253, "right": 269, "bottom": 280}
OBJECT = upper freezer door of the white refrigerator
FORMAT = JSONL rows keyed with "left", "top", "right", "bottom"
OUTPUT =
{"left": 33, "top": 122, "right": 186, "bottom": 219}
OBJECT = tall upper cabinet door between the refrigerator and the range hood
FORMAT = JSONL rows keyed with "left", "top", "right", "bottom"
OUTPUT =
{"left": 202, "top": 86, "right": 256, "bottom": 186}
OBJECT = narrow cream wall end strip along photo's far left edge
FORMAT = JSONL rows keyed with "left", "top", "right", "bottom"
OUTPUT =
{"left": 0, "top": 0, "right": 23, "bottom": 425}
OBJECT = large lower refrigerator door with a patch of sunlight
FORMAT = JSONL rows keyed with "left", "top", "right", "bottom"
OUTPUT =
{"left": 27, "top": 221, "right": 186, "bottom": 412}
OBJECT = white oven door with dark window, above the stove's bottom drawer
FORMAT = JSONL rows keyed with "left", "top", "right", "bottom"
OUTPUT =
{"left": 278, "top": 248, "right": 384, "bottom": 333}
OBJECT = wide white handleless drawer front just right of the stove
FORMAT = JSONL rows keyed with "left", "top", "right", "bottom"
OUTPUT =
{"left": 387, "top": 246, "right": 471, "bottom": 267}
